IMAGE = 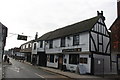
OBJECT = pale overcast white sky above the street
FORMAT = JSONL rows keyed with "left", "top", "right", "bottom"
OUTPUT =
{"left": 0, "top": 0, "right": 117, "bottom": 50}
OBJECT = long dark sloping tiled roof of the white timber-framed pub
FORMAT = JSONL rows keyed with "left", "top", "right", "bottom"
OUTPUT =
{"left": 38, "top": 16, "right": 101, "bottom": 40}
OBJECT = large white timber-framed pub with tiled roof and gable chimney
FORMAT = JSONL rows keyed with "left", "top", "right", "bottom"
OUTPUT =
{"left": 42, "top": 11, "right": 111, "bottom": 74}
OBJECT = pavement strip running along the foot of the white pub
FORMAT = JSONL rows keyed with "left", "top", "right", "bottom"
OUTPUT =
{"left": 11, "top": 59, "right": 120, "bottom": 79}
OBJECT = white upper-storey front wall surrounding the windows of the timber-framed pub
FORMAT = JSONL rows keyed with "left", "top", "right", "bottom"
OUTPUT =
{"left": 46, "top": 32, "right": 89, "bottom": 53}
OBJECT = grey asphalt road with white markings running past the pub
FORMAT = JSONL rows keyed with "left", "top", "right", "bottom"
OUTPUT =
{"left": 4, "top": 59, "right": 69, "bottom": 80}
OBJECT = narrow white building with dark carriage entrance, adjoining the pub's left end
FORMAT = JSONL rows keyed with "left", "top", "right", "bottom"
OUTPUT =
{"left": 32, "top": 33, "right": 50, "bottom": 66}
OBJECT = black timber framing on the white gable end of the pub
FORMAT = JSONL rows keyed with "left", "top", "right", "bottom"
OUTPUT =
{"left": 89, "top": 19, "right": 112, "bottom": 75}
